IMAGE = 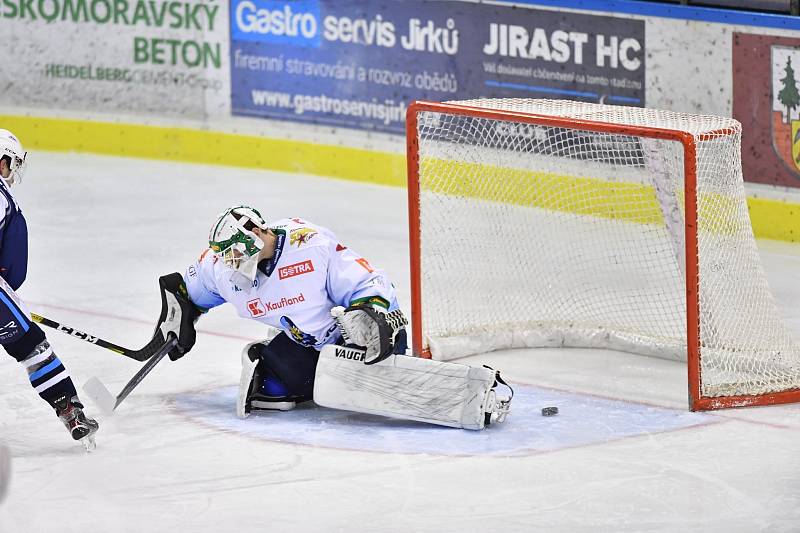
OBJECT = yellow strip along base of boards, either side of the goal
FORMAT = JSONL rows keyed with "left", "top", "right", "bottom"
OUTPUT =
{"left": 0, "top": 115, "right": 800, "bottom": 242}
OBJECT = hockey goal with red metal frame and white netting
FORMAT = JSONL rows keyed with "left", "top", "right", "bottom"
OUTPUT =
{"left": 407, "top": 99, "right": 800, "bottom": 410}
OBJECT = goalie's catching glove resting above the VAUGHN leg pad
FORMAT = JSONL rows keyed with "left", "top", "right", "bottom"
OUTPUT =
{"left": 331, "top": 303, "right": 408, "bottom": 365}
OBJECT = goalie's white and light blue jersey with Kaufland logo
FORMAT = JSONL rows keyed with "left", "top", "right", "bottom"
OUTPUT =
{"left": 184, "top": 218, "right": 398, "bottom": 350}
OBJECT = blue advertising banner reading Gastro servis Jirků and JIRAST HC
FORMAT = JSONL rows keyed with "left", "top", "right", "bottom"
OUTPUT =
{"left": 230, "top": 0, "right": 645, "bottom": 133}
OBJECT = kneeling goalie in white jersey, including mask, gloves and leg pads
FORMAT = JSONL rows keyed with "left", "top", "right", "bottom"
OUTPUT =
{"left": 156, "top": 205, "right": 510, "bottom": 429}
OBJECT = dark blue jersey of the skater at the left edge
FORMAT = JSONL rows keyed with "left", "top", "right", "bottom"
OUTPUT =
{"left": 0, "top": 180, "right": 28, "bottom": 290}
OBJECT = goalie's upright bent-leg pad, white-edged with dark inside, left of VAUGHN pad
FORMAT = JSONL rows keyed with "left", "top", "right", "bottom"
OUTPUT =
{"left": 236, "top": 331, "right": 296, "bottom": 418}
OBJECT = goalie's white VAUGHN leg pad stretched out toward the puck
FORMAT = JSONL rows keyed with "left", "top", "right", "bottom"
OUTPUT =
{"left": 314, "top": 346, "right": 509, "bottom": 429}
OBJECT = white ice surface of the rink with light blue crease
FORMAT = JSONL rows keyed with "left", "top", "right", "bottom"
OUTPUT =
{"left": 0, "top": 153, "right": 800, "bottom": 533}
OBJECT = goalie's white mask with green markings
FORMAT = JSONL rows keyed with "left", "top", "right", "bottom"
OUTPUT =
{"left": 208, "top": 205, "right": 269, "bottom": 281}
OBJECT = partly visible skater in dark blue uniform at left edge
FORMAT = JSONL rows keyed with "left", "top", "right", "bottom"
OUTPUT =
{"left": 0, "top": 129, "right": 98, "bottom": 450}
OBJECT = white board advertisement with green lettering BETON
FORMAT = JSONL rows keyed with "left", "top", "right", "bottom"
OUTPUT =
{"left": 0, "top": 0, "right": 230, "bottom": 119}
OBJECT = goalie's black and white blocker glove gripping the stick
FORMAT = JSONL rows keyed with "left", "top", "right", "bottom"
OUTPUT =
{"left": 155, "top": 272, "right": 202, "bottom": 361}
